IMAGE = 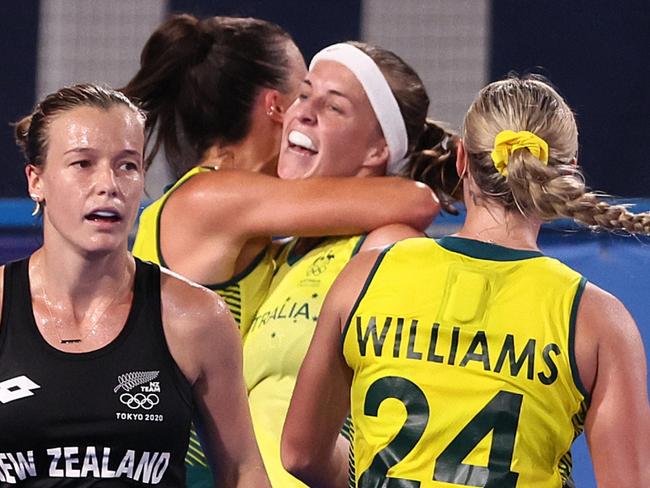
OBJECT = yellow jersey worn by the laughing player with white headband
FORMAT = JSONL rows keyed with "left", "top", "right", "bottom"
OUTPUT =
{"left": 244, "top": 236, "right": 363, "bottom": 488}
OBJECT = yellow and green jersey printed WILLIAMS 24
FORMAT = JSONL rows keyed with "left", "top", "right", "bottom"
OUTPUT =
{"left": 342, "top": 237, "right": 588, "bottom": 488}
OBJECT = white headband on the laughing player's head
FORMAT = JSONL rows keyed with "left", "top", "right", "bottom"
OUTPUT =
{"left": 309, "top": 43, "right": 408, "bottom": 174}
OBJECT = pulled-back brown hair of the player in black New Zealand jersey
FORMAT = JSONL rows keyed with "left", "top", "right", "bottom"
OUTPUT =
{"left": 15, "top": 83, "right": 145, "bottom": 167}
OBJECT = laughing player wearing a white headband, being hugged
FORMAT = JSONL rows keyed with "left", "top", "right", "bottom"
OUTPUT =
{"left": 244, "top": 43, "right": 455, "bottom": 488}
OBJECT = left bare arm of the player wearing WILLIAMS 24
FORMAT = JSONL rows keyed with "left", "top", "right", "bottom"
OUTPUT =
{"left": 281, "top": 251, "right": 378, "bottom": 488}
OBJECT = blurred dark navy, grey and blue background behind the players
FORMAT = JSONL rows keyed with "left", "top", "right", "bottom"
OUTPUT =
{"left": 0, "top": 0, "right": 650, "bottom": 488}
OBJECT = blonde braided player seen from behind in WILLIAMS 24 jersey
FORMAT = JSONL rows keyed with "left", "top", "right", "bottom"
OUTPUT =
{"left": 282, "top": 78, "right": 650, "bottom": 488}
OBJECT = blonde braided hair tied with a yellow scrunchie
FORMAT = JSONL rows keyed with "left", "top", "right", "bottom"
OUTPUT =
{"left": 463, "top": 77, "right": 650, "bottom": 234}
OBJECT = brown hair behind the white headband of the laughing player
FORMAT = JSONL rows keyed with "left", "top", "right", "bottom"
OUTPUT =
{"left": 349, "top": 41, "right": 459, "bottom": 213}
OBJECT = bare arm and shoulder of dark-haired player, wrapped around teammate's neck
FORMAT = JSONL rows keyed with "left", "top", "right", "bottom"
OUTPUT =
{"left": 160, "top": 170, "right": 439, "bottom": 283}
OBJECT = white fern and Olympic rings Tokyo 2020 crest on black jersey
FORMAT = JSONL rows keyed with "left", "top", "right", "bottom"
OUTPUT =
{"left": 113, "top": 371, "right": 162, "bottom": 421}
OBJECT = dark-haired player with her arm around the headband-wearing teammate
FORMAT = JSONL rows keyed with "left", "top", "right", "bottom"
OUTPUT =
{"left": 123, "top": 15, "right": 438, "bottom": 488}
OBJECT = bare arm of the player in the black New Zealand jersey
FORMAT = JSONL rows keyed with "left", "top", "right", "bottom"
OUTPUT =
{"left": 163, "top": 276, "right": 270, "bottom": 488}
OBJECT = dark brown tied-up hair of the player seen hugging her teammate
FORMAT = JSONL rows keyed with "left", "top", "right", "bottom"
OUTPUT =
{"left": 122, "top": 14, "right": 292, "bottom": 177}
